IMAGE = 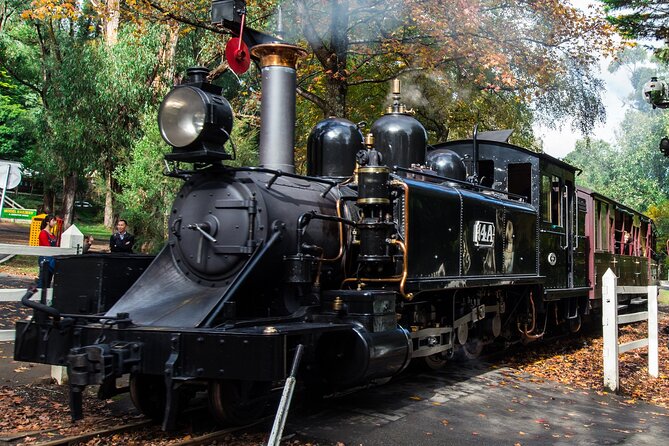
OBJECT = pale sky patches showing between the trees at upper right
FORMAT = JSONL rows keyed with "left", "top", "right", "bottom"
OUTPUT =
{"left": 534, "top": 0, "right": 633, "bottom": 158}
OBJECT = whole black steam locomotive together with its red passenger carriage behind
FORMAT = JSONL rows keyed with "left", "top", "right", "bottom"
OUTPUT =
{"left": 15, "top": 0, "right": 657, "bottom": 428}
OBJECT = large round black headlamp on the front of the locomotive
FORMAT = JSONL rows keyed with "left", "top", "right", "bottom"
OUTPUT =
{"left": 158, "top": 68, "right": 232, "bottom": 162}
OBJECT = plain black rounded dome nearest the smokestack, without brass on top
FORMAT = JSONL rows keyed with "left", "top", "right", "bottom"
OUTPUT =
{"left": 307, "top": 118, "right": 364, "bottom": 178}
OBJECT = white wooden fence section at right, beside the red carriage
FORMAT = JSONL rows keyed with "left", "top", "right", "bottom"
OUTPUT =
{"left": 602, "top": 269, "right": 659, "bottom": 392}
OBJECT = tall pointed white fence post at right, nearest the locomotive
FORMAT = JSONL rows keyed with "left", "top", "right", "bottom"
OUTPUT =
{"left": 602, "top": 268, "right": 619, "bottom": 392}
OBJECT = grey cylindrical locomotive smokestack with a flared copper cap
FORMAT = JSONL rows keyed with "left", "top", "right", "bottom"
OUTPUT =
{"left": 251, "top": 43, "right": 307, "bottom": 173}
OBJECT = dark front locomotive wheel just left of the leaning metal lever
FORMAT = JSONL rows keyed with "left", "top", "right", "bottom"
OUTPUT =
{"left": 209, "top": 380, "right": 272, "bottom": 426}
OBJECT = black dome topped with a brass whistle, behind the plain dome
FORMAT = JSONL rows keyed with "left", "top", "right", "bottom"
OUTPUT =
{"left": 370, "top": 79, "right": 427, "bottom": 168}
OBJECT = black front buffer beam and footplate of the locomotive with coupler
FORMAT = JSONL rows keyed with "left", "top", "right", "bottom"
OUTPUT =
{"left": 14, "top": 321, "right": 352, "bottom": 429}
